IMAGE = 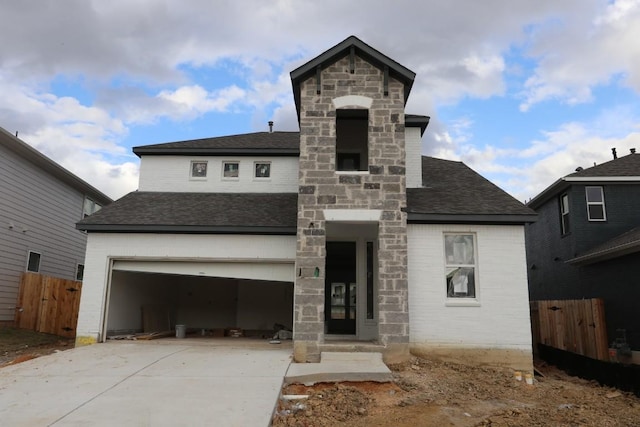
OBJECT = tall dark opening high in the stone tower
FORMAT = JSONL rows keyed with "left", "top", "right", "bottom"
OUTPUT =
{"left": 336, "top": 110, "right": 369, "bottom": 171}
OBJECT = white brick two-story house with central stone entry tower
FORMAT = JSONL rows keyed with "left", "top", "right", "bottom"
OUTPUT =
{"left": 77, "top": 37, "right": 535, "bottom": 370}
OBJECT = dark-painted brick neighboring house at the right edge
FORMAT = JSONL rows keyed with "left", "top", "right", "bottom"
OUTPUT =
{"left": 526, "top": 150, "right": 640, "bottom": 358}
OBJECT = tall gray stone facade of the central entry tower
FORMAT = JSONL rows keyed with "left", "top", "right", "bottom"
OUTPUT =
{"left": 294, "top": 52, "right": 409, "bottom": 362}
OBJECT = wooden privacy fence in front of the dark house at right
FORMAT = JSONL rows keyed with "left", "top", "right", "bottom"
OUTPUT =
{"left": 530, "top": 298, "right": 609, "bottom": 361}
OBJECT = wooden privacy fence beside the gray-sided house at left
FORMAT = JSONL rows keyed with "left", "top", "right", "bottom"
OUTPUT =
{"left": 15, "top": 273, "right": 82, "bottom": 338}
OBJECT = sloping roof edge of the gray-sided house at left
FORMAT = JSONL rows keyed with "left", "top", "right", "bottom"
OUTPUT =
{"left": 0, "top": 127, "right": 112, "bottom": 205}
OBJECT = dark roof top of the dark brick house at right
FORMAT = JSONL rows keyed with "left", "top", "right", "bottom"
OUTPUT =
{"left": 527, "top": 153, "right": 640, "bottom": 209}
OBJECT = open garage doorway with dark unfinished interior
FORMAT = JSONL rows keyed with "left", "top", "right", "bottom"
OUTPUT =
{"left": 105, "top": 270, "right": 293, "bottom": 338}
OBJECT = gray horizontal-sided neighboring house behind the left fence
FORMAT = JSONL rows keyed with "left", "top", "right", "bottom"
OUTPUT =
{"left": 0, "top": 128, "right": 111, "bottom": 323}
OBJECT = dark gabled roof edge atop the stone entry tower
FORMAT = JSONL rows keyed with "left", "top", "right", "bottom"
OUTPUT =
{"left": 291, "top": 36, "right": 416, "bottom": 118}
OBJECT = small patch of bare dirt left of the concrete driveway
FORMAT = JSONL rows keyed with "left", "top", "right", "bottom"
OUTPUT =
{"left": 0, "top": 327, "right": 74, "bottom": 368}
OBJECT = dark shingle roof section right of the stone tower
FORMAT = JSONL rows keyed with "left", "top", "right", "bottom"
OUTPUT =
{"left": 407, "top": 157, "right": 537, "bottom": 224}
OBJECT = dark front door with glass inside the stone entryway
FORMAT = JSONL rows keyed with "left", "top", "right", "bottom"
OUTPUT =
{"left": 325, "top": 242, "right": 357, "bottom": 335}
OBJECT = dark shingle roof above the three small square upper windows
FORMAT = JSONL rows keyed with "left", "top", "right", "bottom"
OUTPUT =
{"left": 133, "top": 132, "right": 300, "bottom": 156}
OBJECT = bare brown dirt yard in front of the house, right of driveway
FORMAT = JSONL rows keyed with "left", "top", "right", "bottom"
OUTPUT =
{"left": 273, "top": 358, "right": 640, "bottom": 427}
